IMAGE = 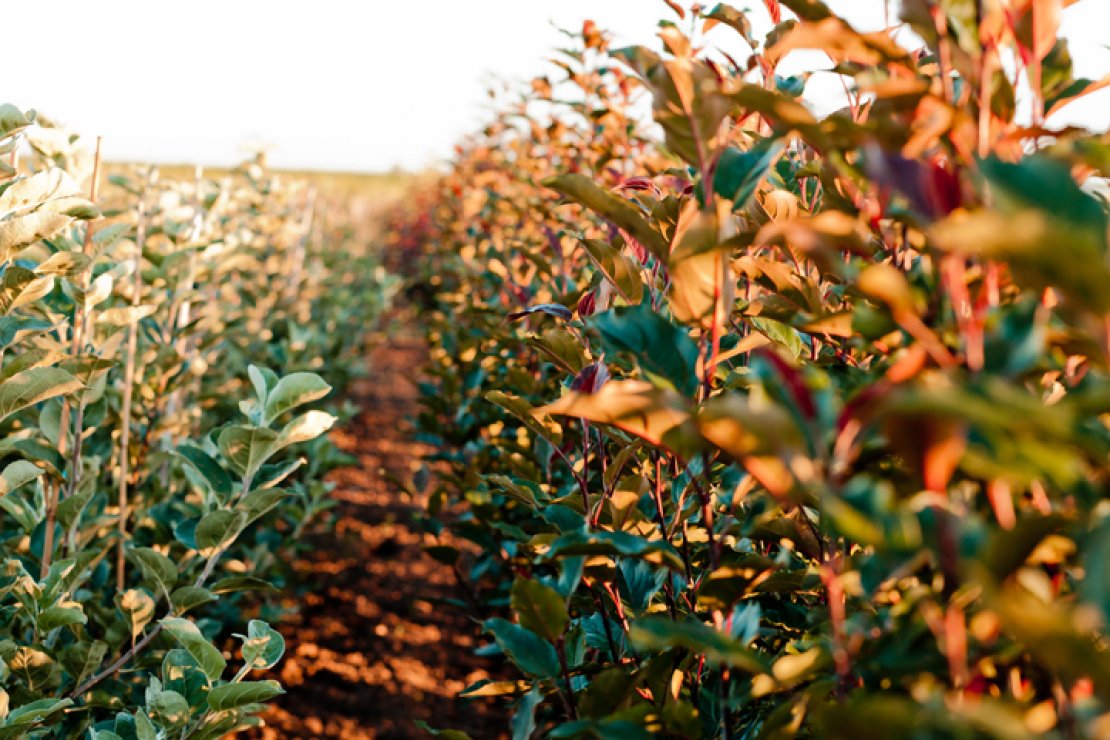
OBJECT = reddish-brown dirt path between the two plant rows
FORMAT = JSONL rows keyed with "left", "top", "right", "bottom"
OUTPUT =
{"left": 255, "top": 338, "right": 505, "bottom": 738}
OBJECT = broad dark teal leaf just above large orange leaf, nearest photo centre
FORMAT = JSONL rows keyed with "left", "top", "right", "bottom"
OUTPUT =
{"left": 589, "top": 303, "right": 698, "bottom": 396}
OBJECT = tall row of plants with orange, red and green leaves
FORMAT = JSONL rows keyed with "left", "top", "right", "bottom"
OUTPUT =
{"left": 402, "top": 0, "right": 1110, "bottom": 738}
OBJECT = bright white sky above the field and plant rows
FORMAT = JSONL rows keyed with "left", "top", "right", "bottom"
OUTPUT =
{"left": 8, "top": 0, "right": 1110, "bottom": 171}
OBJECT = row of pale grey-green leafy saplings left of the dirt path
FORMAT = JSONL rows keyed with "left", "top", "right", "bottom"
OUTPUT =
{"left": 0, "top": 105, "right": 392, "bottom": 740}
